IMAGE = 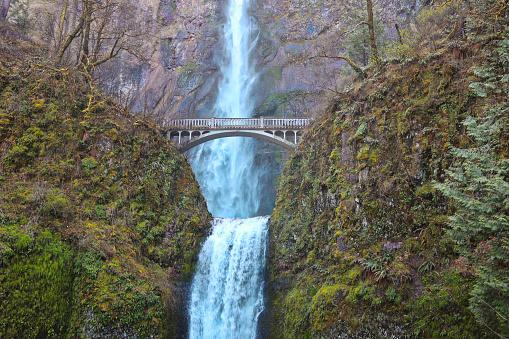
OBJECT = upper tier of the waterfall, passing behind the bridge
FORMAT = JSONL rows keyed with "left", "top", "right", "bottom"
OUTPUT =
{"left": 191, "top": 0, "right": 262, "bottom": 218}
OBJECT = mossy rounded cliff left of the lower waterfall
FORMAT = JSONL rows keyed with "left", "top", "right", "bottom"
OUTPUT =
{"left": 0, "top": 31, "right": 210, "bottom": 338}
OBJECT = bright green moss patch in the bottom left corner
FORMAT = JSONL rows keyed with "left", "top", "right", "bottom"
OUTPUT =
{"left": 0, "top": 231, "right": 73, "bottom": 338}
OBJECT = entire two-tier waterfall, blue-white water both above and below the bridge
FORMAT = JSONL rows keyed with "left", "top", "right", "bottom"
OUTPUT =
{"left": 189, "top": 0, "right": 268, "bottom": 339}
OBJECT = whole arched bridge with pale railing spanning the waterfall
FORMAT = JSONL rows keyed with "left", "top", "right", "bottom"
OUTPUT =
{"left": 164, "top": 117, "right": 311, "bottom": 153}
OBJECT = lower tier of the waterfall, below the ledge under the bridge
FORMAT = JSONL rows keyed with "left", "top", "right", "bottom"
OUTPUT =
{"left": 189, "top": 217, "right": 267, "bottom": 339}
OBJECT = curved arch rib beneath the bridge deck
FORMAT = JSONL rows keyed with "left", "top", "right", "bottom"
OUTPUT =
{"left": 179, "top": 130, "right": 297, "bottom": 152}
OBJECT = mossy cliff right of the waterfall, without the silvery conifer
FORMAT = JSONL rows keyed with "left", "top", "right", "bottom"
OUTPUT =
{"left": 269, "top": 27, "right": 507, "bottom": 338}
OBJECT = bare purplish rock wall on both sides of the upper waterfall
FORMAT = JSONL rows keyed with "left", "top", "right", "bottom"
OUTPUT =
{"left": 88, "top": 0, "right": 420, "bottom": 121}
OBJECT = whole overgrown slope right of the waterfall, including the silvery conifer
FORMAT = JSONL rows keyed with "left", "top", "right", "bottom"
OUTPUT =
{"left": 270, "top": 1, "right": 509, "bottom": 338}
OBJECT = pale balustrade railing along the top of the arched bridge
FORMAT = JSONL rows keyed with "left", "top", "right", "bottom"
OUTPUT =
{"left": 164, "top": 117, "right": 311, "bottom": 130}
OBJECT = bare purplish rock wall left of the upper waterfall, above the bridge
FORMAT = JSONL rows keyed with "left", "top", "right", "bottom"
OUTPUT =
{"left": 99, "top": 0, "right": 224, "bottom": 122}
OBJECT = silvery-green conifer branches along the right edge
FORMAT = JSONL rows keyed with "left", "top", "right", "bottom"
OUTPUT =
{"left": 437, "top": 31, "right": 509, "bottom": 335}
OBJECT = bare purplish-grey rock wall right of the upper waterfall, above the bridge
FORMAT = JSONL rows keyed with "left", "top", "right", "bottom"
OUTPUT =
{"left": 254, "top": 0, "right": 420, "bottom": 116}
